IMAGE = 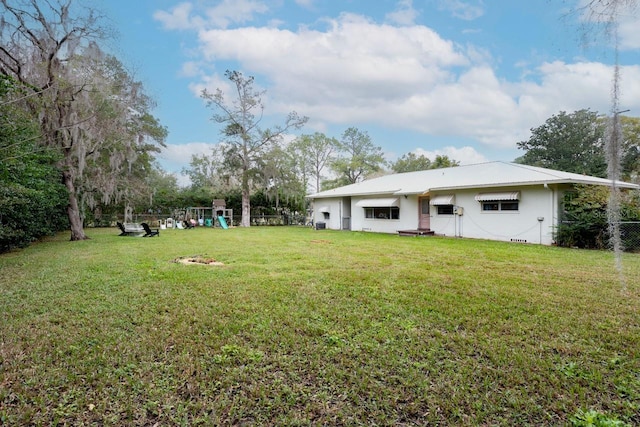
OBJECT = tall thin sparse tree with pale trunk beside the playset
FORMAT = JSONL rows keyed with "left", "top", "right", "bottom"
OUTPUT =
{"left": 201, "top": 70, "right": 307, "bottom": 227}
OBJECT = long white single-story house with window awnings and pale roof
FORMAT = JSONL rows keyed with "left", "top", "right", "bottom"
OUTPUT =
{"left": 308, "top": 161, "right": 640, "bottom": 245}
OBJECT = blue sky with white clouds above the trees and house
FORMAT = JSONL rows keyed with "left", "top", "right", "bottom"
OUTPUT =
{"left": 101, "top": 0, "right": 640, "bottom": 182}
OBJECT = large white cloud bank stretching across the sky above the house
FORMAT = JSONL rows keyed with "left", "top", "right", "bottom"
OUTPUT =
{"left": 158, "top": 6, "right": 640, "bottom": 155}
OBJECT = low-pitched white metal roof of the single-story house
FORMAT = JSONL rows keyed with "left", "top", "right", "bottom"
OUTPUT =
{"left": 308, "top": 161, "right": 640, "bottom": 199}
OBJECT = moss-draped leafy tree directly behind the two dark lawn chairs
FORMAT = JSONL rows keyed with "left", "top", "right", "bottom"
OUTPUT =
{"left": 74, "top": 53, "right": 167, "bottom": 222}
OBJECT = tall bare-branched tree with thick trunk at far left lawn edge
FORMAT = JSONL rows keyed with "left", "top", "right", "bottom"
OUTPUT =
{"left": 0, "top": 0, "right": 107, "bottom": 240}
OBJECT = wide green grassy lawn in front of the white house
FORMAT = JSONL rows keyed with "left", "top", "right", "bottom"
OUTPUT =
{"left": 0, "top": 227, "right": 640, "bottom": 425}
